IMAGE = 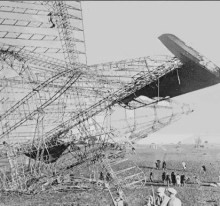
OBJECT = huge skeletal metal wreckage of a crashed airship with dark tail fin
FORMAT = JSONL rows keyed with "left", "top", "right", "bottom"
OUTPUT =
{"left": 0, "top": 1, "right": 220, "bottom": 196}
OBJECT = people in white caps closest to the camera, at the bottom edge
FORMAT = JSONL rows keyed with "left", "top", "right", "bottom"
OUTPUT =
{"left": 144, "top": 187, "right": 182, "bottom": 206}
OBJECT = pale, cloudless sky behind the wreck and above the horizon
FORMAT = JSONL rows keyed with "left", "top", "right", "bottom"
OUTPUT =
{"left": 82, "top": 1, "right": 220, "bottom": 143}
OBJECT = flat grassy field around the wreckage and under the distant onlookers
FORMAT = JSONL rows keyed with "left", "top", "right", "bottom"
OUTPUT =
{"left": 1, "top": 145, "right": 220, "bottom": 206}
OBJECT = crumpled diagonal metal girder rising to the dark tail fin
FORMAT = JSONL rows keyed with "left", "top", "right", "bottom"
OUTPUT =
{"left": 45, "top": 58, "right": 182, "bottom": 142}
